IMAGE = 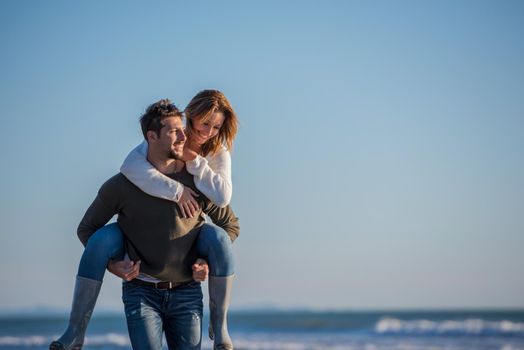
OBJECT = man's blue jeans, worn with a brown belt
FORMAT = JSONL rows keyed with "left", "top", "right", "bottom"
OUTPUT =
{"left": 122, "top": 282, "right": 202, "bottom": 350}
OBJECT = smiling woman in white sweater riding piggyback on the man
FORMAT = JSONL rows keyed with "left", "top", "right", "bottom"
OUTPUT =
{"left": 49, "top": 90, "right": 238, "bottom": 350}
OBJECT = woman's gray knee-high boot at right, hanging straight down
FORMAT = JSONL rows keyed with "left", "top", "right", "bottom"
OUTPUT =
{"left": 208, "top": 275, "right": 235, "bottom": 350}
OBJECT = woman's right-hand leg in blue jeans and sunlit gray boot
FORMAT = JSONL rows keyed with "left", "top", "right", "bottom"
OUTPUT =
{"left": 196, "top": 224, "right": 235, "bottom": 350}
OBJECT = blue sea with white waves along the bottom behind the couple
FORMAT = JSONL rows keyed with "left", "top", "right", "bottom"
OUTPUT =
{"left": 0, "top": 310, "right": 524, "bottom": 350}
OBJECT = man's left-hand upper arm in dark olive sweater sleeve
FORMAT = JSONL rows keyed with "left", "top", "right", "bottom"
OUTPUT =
{"left": 77, "top": 175, "right": 120, "bottom": 247}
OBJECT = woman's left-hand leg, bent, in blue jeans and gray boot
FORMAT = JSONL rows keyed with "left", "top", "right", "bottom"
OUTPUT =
{"left": 49, "top": 224, "right": 124, "bottom": 350}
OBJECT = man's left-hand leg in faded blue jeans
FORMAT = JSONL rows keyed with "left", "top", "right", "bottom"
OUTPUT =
{"left": 122, "top": 282, "right": 162, "bottom": 350}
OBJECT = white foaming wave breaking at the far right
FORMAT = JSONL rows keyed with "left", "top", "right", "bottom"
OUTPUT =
{"left": 375, "top": 317, "right": 524, "bottom": 336}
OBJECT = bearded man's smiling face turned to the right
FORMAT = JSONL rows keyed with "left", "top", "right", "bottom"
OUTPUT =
{"left": 150, "top": 117, "right": 186, "bottom": 159}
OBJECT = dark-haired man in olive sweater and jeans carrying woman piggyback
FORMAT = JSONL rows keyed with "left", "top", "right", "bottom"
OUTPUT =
{"left": 78, "top": 100, "right": 239, "bottom": 349}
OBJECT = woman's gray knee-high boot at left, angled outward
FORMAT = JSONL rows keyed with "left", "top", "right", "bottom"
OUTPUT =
{"left": 49, "top": 276, "right": 102, "bottom": 350}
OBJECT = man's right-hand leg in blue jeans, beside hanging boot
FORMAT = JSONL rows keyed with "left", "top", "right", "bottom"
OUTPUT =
{"left": 164, "top": 282, "right": 202, "bottom": 350}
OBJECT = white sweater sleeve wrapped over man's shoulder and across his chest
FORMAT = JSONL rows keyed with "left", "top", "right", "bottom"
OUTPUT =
{"left": 120, "top": 141, "right": 184, "bottom": 202}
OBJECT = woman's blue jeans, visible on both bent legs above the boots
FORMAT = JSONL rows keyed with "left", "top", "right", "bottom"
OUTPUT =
{"left": 78, "top": 223, "right": 235, "bottom": 281}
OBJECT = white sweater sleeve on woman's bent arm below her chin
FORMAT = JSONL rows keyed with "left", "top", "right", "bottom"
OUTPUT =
{"left": 186, "top": 147, "right": 233, "bottom": 208}
